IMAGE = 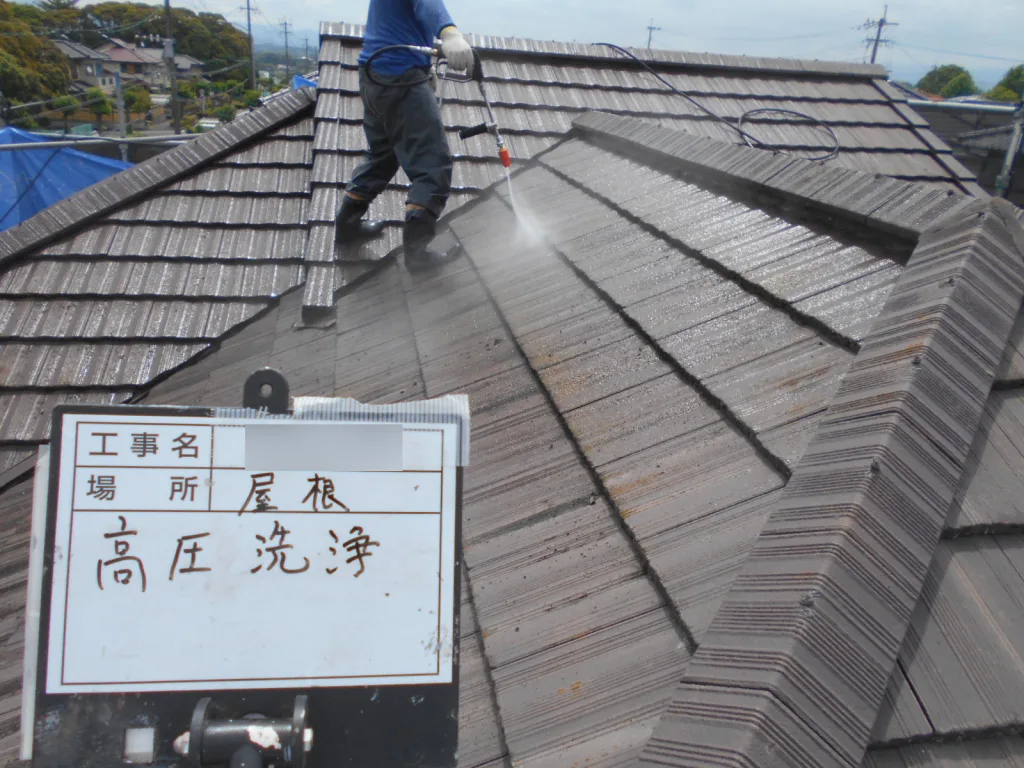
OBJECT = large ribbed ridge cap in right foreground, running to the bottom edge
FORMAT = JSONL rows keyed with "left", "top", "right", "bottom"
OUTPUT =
{"left": 640, "top": 199, "right": 1024, "bottom": 768}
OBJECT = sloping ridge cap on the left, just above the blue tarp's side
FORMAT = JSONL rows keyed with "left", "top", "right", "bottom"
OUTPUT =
{"left": 0, "top": 88, "right": 315, "bottom": 268}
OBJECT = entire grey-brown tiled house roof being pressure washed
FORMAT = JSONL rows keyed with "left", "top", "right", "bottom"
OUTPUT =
{"left": 0, "top": 25, "right": 1024, "bottom": 768}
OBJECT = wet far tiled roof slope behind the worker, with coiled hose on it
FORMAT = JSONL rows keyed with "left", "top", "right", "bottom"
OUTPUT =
{"left": 305, "top": 24, "right": 980, "bottom": 310}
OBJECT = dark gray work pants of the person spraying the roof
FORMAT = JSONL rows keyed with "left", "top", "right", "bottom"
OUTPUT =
{"left": 347, "top": 69, "right": 452, "bottom": 217}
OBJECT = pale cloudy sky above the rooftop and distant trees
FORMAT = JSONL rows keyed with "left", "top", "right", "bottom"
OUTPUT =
{"left": 157, "top": 0, "right": 1024, "bottom": 88}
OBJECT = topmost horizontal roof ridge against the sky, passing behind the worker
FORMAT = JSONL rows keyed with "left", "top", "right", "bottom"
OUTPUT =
{"left": 319, "top": 22, "right": 889, "bottom": 80}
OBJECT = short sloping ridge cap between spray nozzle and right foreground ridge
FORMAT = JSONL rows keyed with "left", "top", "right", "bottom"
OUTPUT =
{"left": 572, "top": 111, "right": 975, "bottom": 240}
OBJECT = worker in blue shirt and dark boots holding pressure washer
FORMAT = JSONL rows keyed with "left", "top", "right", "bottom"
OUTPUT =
{"left": 337, "top": 0, "right": 473, "bottom": 270}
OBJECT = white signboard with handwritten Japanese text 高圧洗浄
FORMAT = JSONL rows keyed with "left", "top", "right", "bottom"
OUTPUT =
{"left": 46, "top": 414, "right": 459, "bottom": 694}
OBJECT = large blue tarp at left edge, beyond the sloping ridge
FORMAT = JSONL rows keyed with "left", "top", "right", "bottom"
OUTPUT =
{"left": 0, "top": 128, "right": 132, "bottom": 230}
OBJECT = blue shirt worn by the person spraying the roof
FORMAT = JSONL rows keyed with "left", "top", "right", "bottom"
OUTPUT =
{"left": 359, "top": 0, "right": 455, "bottom": 75}
